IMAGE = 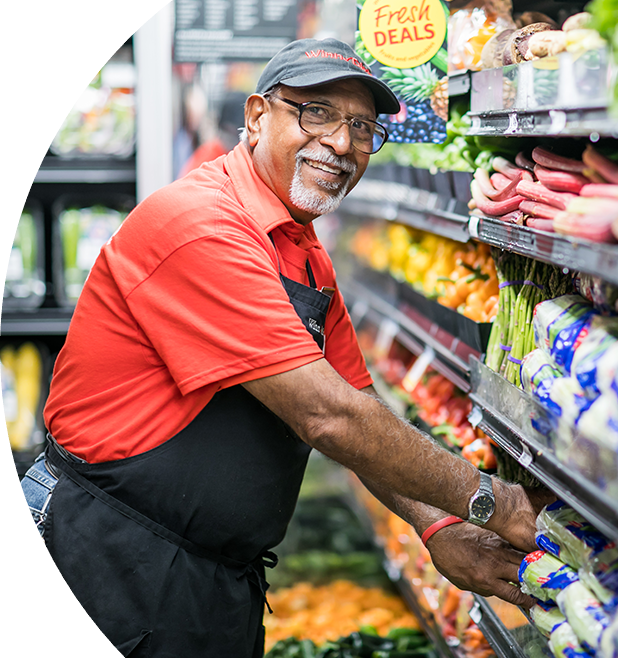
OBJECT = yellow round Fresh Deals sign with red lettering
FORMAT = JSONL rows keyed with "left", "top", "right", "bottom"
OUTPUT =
{"left": 358, "top": 0, "right": 446, "bottom": 69}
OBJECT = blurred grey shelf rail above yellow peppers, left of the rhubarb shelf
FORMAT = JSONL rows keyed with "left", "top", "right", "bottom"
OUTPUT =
{"left": 341, "top": 179, "right": 470, "bottom": 242}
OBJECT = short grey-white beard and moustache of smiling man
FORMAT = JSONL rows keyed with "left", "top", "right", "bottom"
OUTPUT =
{"left": 290, "top": 149, "right": 356, "bottom": 215}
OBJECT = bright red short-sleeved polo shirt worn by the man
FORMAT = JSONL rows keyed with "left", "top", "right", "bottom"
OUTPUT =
{"left": 45, "top": 145, "right": 371, "bottom": 462}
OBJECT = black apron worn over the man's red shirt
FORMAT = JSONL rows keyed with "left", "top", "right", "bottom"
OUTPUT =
{"left": 28, "top": 252, "right": 330, "bottom": 658}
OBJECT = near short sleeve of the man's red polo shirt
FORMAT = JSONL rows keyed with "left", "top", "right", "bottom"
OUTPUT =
{"left": 122, "top": 227, "right": 322, "bottom": 395}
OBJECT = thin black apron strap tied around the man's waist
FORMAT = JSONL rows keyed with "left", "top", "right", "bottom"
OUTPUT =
{"left": 45, "top": 433, "right": 278, "bottom": 612}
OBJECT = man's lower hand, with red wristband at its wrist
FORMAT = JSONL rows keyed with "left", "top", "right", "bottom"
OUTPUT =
{"left": 427, "top": 523, "right": 534, "bottom": 608}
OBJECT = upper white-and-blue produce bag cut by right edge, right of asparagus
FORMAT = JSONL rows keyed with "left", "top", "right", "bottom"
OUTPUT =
{"left": 571, "top": 315, "right": 618, "bottom": 399}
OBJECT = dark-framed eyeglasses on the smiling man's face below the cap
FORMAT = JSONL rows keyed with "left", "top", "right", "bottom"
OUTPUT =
{"left": 270, "top": 95, "right": 388, "bottom": 155}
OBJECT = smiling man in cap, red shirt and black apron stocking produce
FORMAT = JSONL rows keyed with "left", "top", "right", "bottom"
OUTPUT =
{"left": 0, "top": 39, "right": 538, "bottom": 658}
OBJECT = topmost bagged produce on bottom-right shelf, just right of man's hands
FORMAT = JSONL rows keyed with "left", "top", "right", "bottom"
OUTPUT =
{"left": 537, "top": 501, "right": 618, "bottom": 610}
